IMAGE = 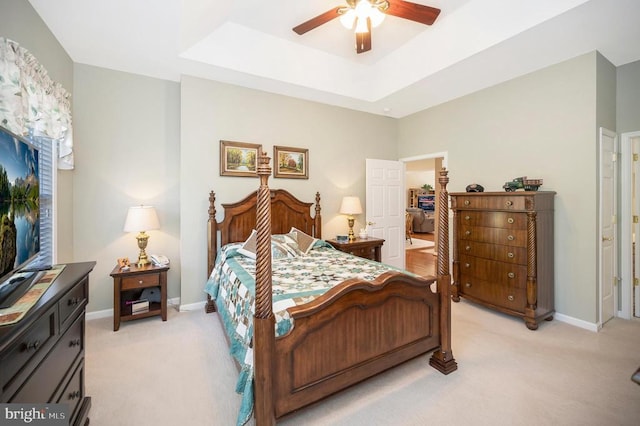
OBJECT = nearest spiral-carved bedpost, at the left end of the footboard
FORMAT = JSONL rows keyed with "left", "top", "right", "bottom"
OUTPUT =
{"left": 253, "top": 153, "right": 276, "bottom": 426}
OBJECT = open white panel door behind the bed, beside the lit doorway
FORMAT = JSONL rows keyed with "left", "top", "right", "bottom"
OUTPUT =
{"left": 366, "top": 159, "right": 405, "bottom": 269}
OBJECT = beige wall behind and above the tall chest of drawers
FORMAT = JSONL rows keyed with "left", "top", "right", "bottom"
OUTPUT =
{"left": 398, "top": 52, "right": 604, "bottom": 323}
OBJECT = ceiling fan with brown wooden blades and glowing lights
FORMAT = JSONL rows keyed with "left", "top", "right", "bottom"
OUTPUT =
{"left": 293, "top": 0, "right": 440, "bottom": 53}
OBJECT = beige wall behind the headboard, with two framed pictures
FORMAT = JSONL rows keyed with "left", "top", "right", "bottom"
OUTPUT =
{"left": 180, "top": 76, "right": 398, "bottom": 304}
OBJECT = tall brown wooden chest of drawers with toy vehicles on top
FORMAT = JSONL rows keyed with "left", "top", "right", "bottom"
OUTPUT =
{"left": 450, "top": 191, "right": 555, "bottom": 330}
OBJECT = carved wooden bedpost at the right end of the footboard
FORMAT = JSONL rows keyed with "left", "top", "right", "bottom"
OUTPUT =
{"left": 429, "top": 168, "right": 458, "bottom": 374}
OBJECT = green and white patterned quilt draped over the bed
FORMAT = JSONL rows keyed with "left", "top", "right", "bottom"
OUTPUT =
{"left": 205, "top": 240, "right": 404, "bottom": 425}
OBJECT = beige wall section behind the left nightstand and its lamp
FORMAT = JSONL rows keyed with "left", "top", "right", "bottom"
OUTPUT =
{"left": 73, "top": 64, "right": 180, "bottom": 312}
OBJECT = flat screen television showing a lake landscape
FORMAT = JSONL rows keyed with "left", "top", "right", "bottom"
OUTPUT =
{"left": 0, "top": 126, "right": 40, "bottom": 308}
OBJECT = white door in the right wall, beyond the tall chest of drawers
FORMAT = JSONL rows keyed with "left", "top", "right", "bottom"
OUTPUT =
{"left": 599, "top": 127, "right": 618, "bottom": 324}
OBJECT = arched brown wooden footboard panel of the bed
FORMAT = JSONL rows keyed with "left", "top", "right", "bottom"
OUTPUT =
{"left": 273, "top": 272, "right": 440, "bottom": 418}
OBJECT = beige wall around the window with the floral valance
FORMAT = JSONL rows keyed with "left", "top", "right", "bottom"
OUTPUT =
{"left": 0, "top": 0, "right": 75, "bottom": 263}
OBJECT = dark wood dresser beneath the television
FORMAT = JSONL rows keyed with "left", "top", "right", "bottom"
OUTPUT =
{"left": 0, "top": 262, "right": 95, "bottom": 426}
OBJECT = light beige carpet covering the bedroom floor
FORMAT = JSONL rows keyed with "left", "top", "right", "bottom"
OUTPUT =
{"left": 86, "top": 301, "right": 640, "bottom": 426}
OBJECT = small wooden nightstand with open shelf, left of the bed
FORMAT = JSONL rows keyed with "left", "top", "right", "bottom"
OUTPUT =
{"left": 111, "top": 264, "right": 169, "bottom": 331}
